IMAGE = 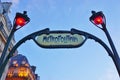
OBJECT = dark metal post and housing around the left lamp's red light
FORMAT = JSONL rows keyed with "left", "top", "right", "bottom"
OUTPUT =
{"left": 0, "top": 11, "right": 30, "bottom": 78}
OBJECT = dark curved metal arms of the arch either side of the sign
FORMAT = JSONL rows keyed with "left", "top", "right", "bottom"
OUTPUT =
{"left": 2, "top": 28, "right": 118, "bottom": 79}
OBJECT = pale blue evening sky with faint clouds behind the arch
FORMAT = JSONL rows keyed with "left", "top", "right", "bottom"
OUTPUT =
{"left": 2, "top": 0, "right": 120, "bottom": 80}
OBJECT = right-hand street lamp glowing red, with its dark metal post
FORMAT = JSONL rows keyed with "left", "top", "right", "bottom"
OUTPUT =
{"left": 89, "top": 11, "right": 120, "bottom": 76}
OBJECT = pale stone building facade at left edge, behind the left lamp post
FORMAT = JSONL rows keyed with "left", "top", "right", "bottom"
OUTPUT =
{"left": 0, "top": 1, "right": 15, "bottom": 80}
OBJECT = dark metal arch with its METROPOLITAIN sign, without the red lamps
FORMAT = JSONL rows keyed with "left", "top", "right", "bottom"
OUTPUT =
{"left": 2, "top": 28, "right": 120, "bottom": 77}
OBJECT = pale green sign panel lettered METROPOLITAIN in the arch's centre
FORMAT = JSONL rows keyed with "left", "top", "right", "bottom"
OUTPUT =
{"left": 36, "top": 32, "right": 85, "bottom": 48}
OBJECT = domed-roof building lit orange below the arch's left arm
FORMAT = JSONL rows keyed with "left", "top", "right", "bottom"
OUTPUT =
{"left": 6, "top": 54, "right": 39, "bottom": 80}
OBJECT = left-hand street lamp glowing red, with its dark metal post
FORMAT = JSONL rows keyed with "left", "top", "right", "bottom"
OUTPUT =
{"left": 0, "top": 11, "right": 30, "bottom": 78}
